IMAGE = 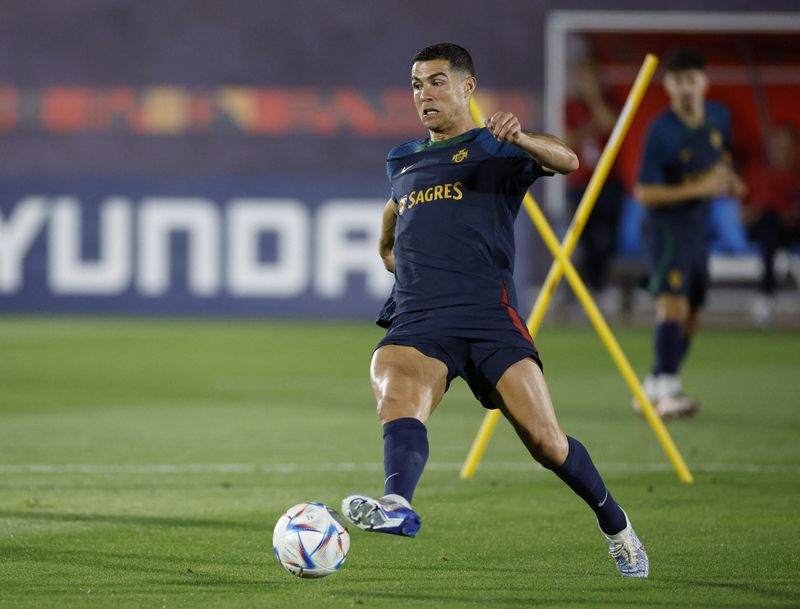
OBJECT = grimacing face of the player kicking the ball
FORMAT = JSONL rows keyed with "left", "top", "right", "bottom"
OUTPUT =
{"left": 411, "top": 59, "right": 475, "bottom": 133}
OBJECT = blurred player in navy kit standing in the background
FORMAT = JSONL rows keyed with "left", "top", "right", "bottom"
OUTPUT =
{"left": 633, "top": 49, "right": 744, "bottom": 419}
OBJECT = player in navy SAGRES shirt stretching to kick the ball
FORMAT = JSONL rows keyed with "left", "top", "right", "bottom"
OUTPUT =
{"left": 342, "top": 44, "right": 648, "bottom": 577}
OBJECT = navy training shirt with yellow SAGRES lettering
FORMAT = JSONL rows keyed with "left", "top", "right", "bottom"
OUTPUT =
{"left": 381, "top": 128, "right": 553, "bottom": 325}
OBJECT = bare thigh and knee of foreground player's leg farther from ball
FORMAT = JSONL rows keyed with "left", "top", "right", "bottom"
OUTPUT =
{"left": 493, "top": 358, "right": 569, "bottom": 466}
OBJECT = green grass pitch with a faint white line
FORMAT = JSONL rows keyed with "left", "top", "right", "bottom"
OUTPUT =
{"left": 0, "top": 317, "right": 800, "bottom": 609}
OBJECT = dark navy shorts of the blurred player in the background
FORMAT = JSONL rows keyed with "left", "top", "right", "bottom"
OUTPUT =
{"left": 644, "top": 218, "right": 709, "bottom": 309}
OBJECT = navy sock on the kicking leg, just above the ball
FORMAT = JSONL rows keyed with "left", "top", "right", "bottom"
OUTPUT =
{"left": 383, "top": 417, "right": 428, "bottom": 503}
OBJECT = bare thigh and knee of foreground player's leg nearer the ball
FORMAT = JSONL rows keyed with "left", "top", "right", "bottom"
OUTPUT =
{"left": 370, "top": 345, "right": 447, "bottom": 425}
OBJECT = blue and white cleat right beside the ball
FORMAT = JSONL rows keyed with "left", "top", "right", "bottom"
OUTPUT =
{"left": 342, "top": 495, "right": 422, "bottom": 537}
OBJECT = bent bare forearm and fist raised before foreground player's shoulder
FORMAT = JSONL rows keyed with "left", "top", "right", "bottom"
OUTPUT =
{"left": 486, "top": 112, "right": 578, "bottom": 174}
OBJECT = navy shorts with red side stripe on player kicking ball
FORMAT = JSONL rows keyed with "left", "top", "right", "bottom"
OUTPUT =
{"left": 375, "top": 304, "right": 542, "bottom": 408}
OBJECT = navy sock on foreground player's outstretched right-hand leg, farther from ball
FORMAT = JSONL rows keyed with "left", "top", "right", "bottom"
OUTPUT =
{"left": 553, "top": 436, "right": 625, "bottom": 535}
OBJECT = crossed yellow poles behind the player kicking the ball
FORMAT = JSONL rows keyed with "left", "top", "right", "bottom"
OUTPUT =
{"left": 461, "top": 54, "right": 694, "bottom": 484}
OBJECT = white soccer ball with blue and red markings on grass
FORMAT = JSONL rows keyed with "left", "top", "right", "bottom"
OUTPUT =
{"left": 272, "top": 501, "right": 350, "bottom": 577}
